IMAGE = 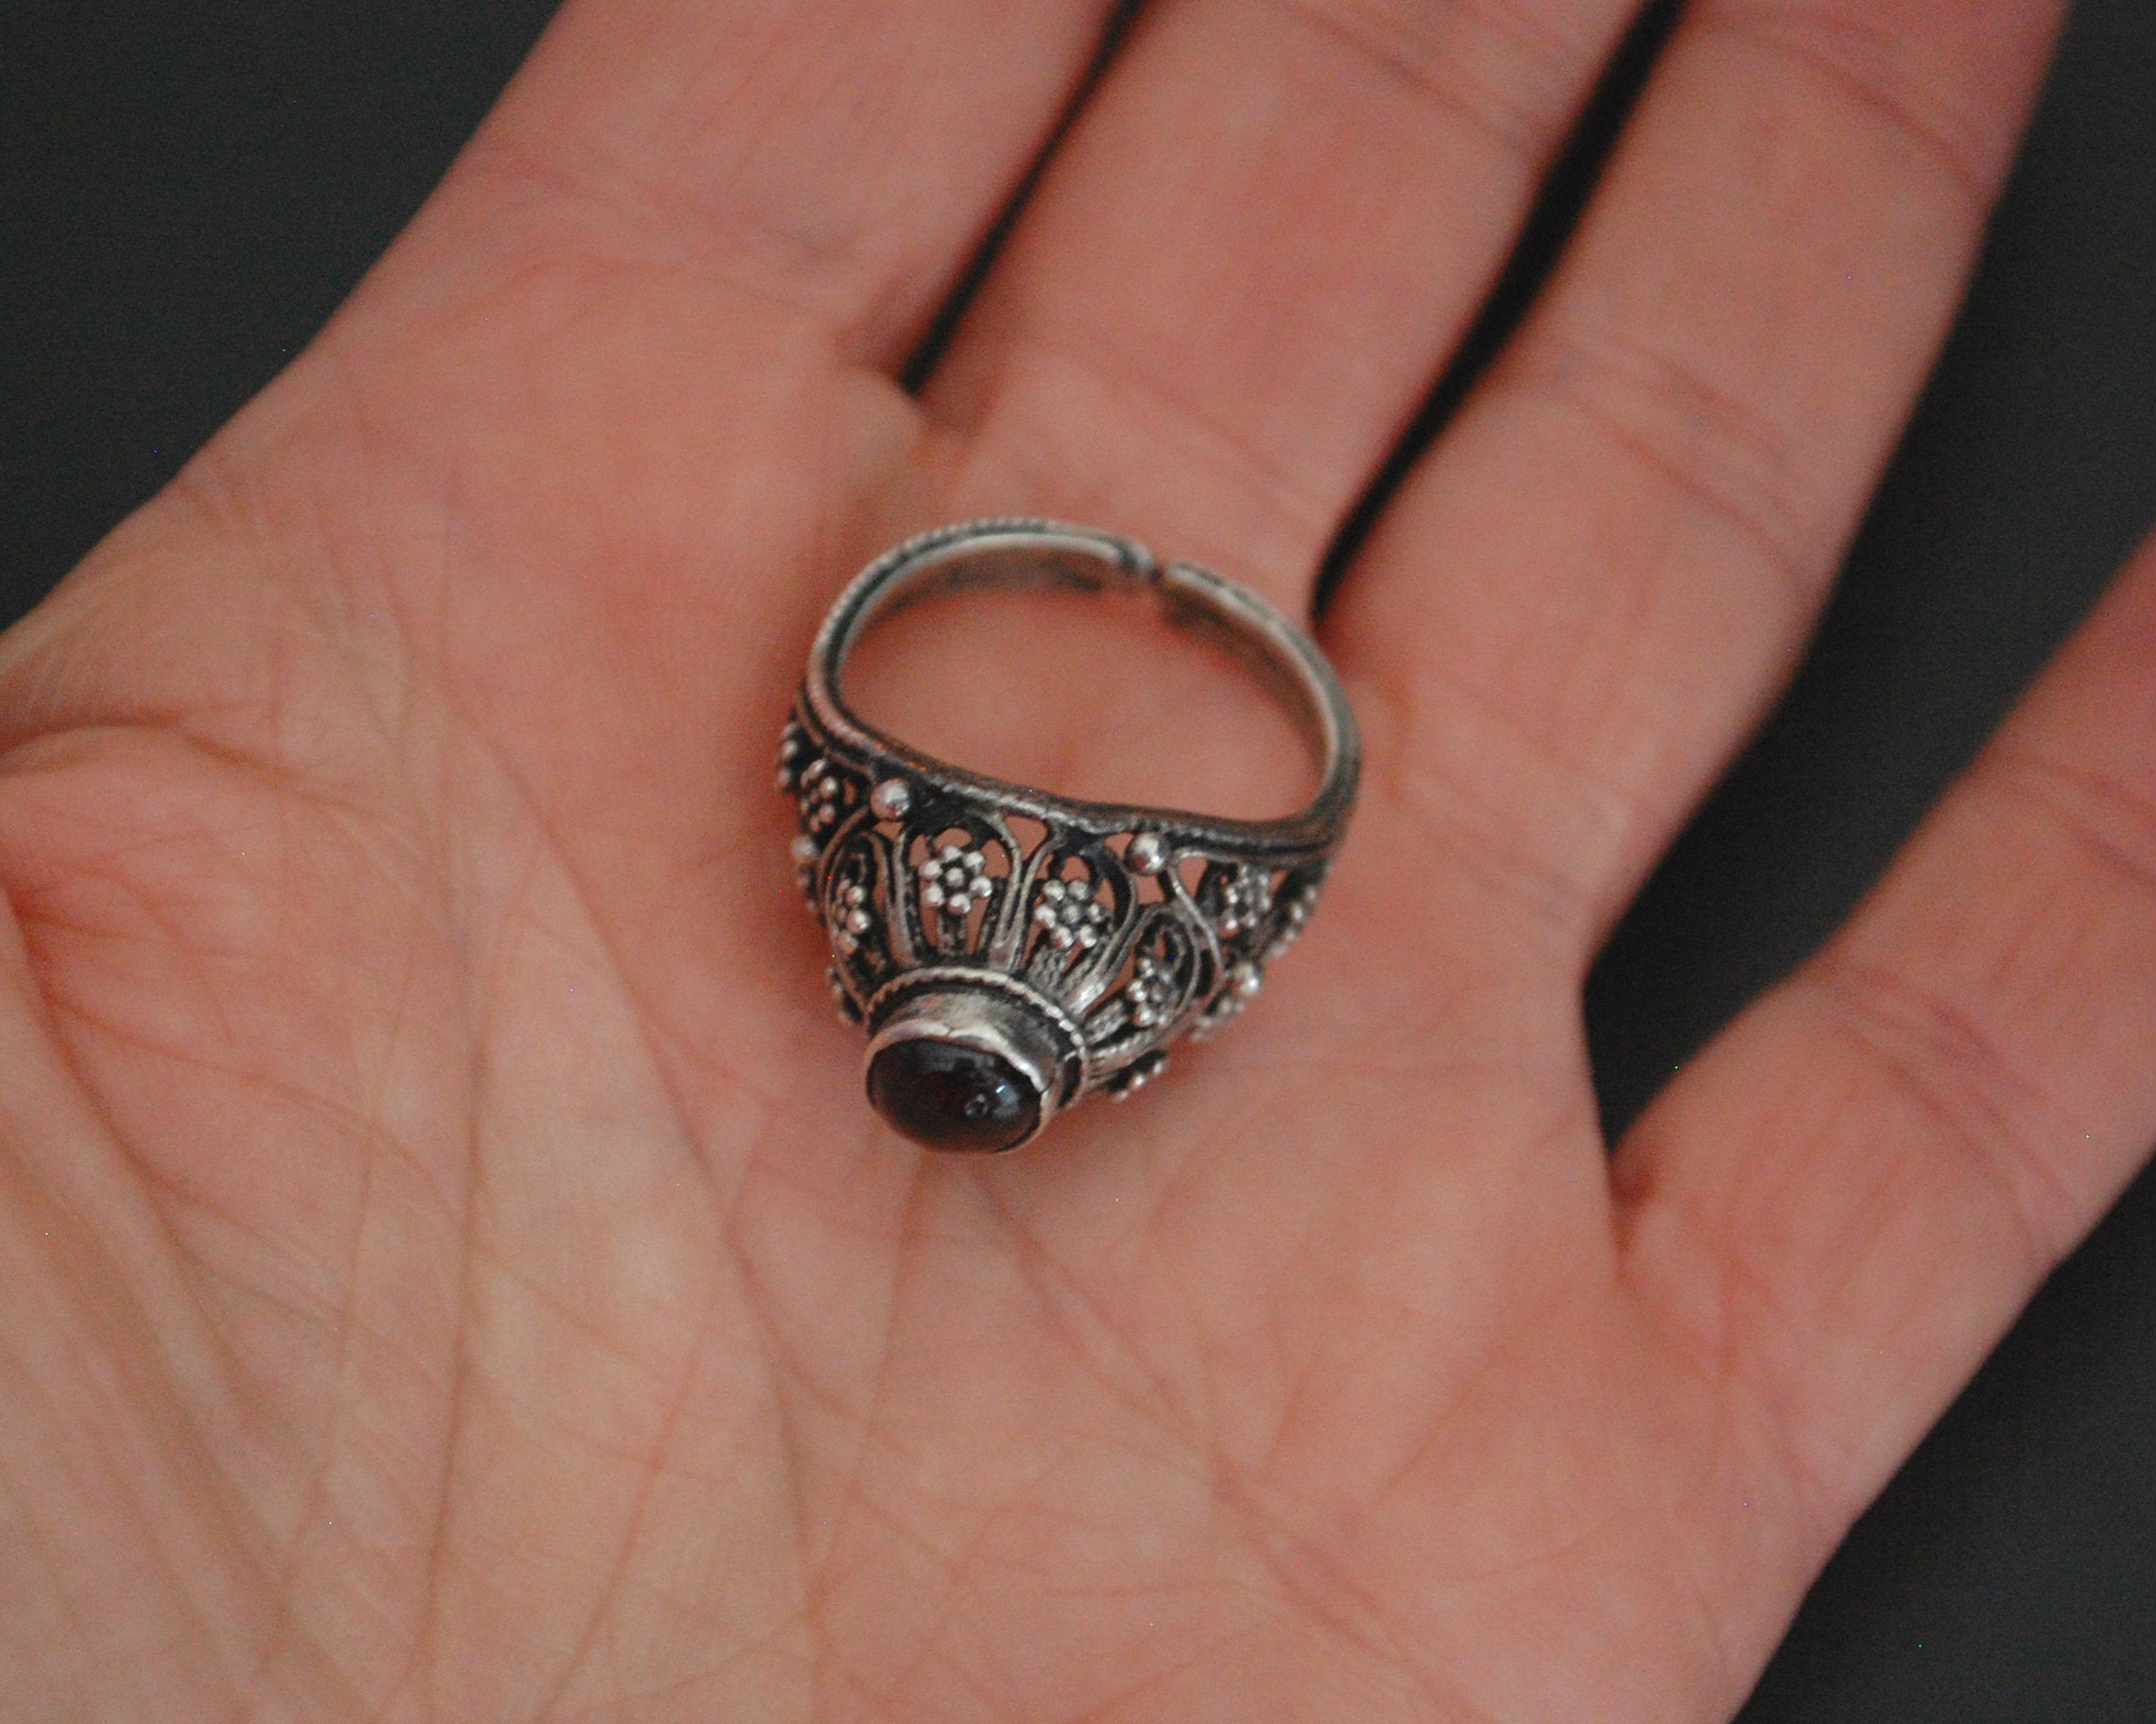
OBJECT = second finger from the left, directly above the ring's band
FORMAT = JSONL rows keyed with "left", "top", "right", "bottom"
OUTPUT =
{"left": 927, "top": 0, "right": 1630, "bottom": 608}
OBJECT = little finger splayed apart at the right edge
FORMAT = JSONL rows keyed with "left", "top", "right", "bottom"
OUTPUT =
{"left": 1617, "top": 527, "right": 2156, "bottom": 1562}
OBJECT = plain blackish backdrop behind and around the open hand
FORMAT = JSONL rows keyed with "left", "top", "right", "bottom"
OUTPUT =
{"left": 0, "top": 0, "right": 2156, "bottom": 1724}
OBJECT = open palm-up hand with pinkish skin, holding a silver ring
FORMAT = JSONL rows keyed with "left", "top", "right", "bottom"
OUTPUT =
{"left": 0, "top": 0, "right": 2156, "bottom": 1724}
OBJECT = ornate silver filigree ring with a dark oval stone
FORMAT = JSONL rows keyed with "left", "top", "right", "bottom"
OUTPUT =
{"left": 778, "top": 519, "right": 1358, "bottom": 1151}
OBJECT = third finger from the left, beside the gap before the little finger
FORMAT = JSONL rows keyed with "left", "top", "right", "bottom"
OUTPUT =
{"left": 1330, "top": 0, "right": 2059, "bottom": 970}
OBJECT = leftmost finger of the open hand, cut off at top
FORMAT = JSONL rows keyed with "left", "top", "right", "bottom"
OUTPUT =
{"left": 357, "top": 0, "right": 1108, "bottom": 367}
